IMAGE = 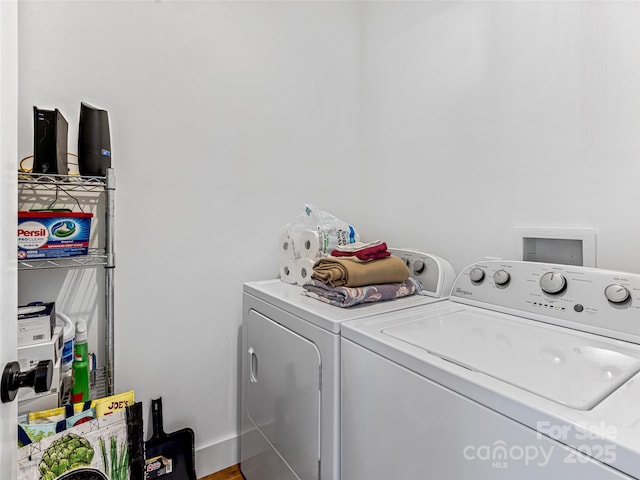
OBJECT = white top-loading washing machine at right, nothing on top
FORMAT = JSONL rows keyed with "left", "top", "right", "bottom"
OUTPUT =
{"left": 341, "top": 261, "right": 640, "bottom": 480}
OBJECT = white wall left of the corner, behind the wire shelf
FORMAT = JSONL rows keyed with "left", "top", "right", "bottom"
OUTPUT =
{"left": 19, "top": 1, "right": 362, "bottom": 476}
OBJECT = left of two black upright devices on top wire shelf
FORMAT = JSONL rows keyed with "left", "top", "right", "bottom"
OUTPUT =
{"left": 32, "top": 107, "right": 69, "bottom": 175}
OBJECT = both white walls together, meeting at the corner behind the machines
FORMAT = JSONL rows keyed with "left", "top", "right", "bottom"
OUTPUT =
{"left": 13, "top": 1, "right": 640, "bottom": 476}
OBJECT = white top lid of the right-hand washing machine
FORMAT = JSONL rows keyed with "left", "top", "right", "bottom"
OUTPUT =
{"left": 382, "top": 310, "right": 640, "bottom": 410}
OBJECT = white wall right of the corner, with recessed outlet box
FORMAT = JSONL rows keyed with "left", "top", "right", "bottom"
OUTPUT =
{"left": 358, "top": 1, "right": 640, "bottom": 272}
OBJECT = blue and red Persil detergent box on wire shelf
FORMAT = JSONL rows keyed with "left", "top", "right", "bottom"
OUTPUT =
{"left": 18, "top": 211, "right": 93, "bottom": 260}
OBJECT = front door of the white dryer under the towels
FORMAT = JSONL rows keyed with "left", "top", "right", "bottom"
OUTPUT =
{"left": 245, "top": 311, "right": 321, "bottom": 480}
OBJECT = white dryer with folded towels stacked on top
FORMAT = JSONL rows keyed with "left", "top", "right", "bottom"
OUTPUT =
{"left": 240, "top": 249, "right": 455, "bottom": 480}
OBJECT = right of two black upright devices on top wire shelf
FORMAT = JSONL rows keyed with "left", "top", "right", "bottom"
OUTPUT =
{"left": 78, "top": 102, "right": 111, "bottom": 177}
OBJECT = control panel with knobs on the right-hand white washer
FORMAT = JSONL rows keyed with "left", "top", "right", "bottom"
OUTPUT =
{"left": 450, "top": 260, "right": 640, "bottom": 344}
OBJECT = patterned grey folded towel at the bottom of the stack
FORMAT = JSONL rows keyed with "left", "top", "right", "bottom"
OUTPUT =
{"left": 302, "top": 277, "right": 422, "bottom": 308}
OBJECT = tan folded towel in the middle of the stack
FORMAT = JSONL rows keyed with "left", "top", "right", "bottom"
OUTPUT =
{"left": 311, "top": 255, "right": 410, "bottom": 287}
